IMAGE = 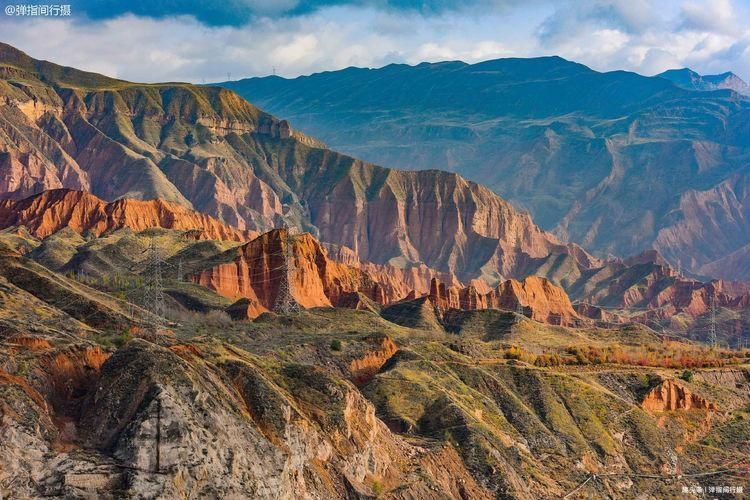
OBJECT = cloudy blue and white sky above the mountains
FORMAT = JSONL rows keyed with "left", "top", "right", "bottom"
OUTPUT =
{"left": 0, "top": 0, "right": 750, "bottom": 83}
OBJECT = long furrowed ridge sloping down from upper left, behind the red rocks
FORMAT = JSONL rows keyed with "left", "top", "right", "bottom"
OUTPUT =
{"left": 0, "top": 46, "right": 592, "bottom": 282}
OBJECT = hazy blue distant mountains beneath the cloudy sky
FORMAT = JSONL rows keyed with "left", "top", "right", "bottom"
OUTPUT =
{"left": 220, "top": 57, "right": 750, "bottom": 279}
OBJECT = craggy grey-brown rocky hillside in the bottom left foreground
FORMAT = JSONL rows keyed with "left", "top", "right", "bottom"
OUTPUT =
{"left": 0, "top": 340, "right": 490, "bottom": 498}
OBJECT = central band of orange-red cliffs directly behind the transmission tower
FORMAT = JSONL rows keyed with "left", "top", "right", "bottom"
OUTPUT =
{"left": 191, "top": 230, "right": 584, "bottom": 326}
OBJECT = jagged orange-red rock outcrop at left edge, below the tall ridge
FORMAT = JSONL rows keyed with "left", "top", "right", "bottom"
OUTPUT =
{"left": 0, "top": 189, "right": 255, "bottom": 241}
